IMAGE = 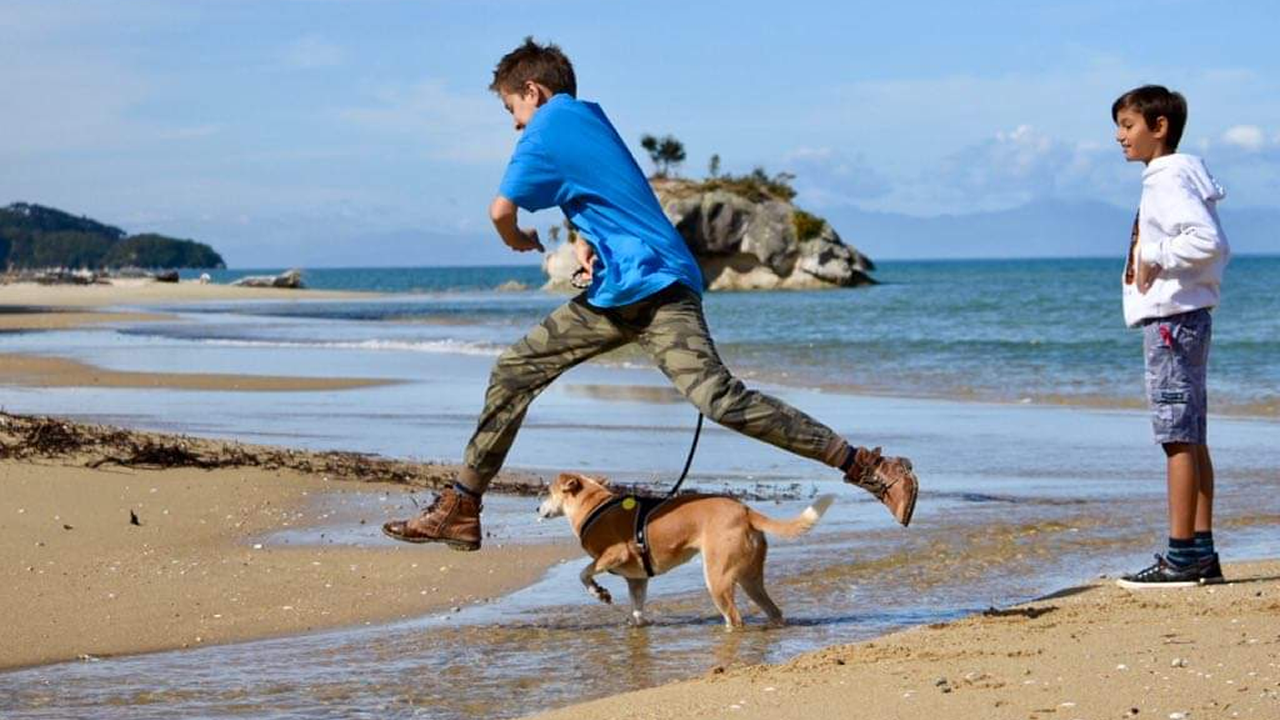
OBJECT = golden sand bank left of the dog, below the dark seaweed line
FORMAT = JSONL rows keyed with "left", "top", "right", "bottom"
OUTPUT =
{"left": 0, "top": 460, "right": 580, "bottom": 669}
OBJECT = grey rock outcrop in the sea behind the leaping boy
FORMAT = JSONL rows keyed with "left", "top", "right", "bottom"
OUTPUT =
{"left": 543, "top": 179, "right": 874, "bottom": 291}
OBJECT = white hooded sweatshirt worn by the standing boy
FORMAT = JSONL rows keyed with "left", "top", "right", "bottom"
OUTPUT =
{"left": 1121, "top": 154, "right": 1231, "bottom": 327}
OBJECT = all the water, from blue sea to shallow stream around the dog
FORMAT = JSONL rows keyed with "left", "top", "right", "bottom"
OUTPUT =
{"left": 0, "top": 258, "right": 1280, "bottom": 719}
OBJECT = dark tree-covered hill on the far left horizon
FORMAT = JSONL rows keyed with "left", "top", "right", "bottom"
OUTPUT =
{"left": 0, "top": 202, "right": 227, "bottom": 270}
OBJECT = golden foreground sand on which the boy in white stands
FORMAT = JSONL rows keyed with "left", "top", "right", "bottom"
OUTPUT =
{"left": 534, "top": 560, "right": 1280, "bottom": 720}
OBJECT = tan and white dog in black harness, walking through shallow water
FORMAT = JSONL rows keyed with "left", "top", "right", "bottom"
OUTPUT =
{"left": 538, "top": 473, "right": 835, "bottom": 629}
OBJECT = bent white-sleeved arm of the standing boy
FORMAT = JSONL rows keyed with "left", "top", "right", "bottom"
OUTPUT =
{"left": 1139, "top": 176, "right": 1226, "bottom": 273}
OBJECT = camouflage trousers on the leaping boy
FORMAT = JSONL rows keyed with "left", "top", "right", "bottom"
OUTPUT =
{"left": 460, "top": 283, "right": 847, "bottom": 492}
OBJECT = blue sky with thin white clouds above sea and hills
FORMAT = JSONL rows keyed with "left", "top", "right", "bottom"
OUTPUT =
{"left": 0, "top": 0, "right": 1280, "bottom": 266}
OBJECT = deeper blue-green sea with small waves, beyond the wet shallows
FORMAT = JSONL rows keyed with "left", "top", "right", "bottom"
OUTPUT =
{"left": 180, "top": 256, "right": 1280, "bottom": 415}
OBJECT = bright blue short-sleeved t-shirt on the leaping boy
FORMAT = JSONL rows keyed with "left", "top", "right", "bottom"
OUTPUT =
{"left": 498, "top": 94, "right": 703, "bottom": 307}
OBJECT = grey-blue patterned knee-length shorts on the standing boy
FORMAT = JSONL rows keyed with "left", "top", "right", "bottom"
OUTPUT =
{"left": 1142, "top": 309, "right": 1213, "bottom": 445}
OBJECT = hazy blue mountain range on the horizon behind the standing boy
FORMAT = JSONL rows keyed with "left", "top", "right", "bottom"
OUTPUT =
{"left": 822, "top": 200, "right": 1280, "bottom": 260}
